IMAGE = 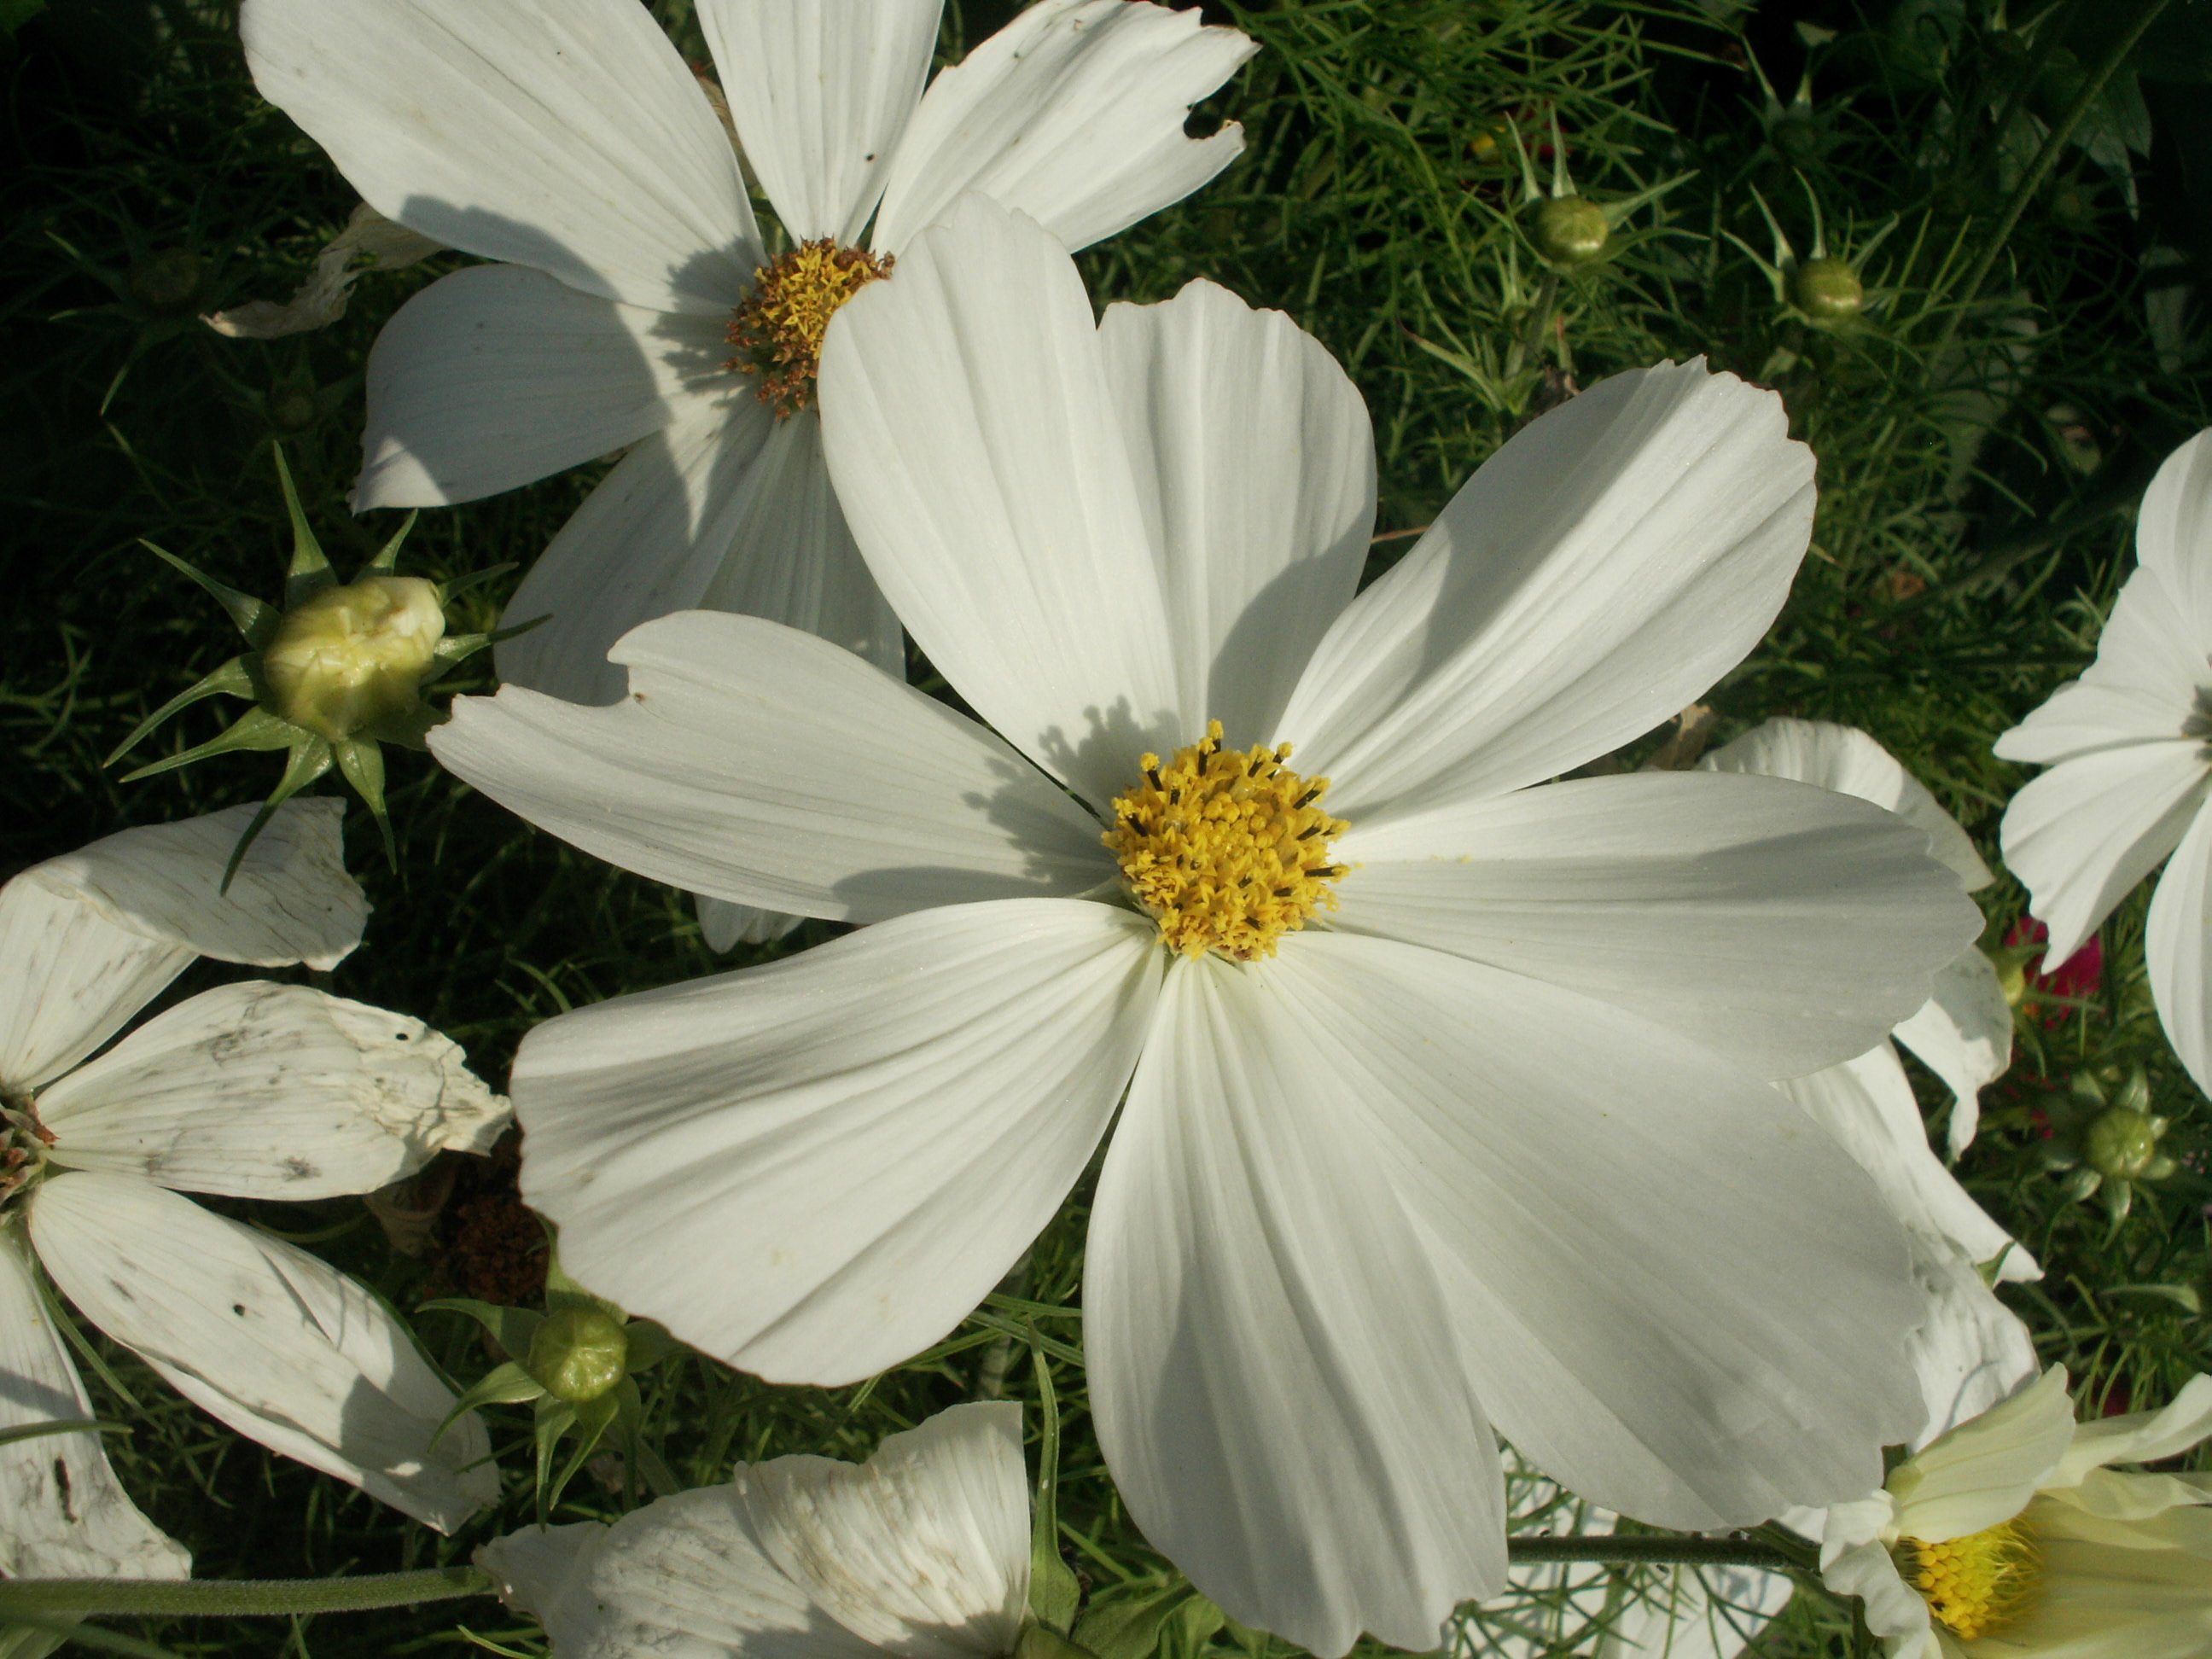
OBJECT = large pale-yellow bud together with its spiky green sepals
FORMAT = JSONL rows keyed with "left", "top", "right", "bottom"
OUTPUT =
{"left": 108, "top": 438, "right": 520, "bottom": 889}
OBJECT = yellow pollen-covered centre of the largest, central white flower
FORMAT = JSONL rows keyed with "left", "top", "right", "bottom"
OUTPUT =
{"left": 1102, "top": 721, "right": 1345, "bottom": 963}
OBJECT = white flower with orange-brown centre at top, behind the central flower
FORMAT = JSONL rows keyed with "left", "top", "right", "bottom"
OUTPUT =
{"left": 239, "top": 0, "right": 1254, "bottom": 703}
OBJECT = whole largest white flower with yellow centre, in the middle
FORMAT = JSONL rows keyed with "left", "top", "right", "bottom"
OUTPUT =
{"left": 431, "top": 197, "right": 1980, "bottom": 1655}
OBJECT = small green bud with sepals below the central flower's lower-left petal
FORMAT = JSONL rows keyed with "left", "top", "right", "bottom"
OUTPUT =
{"left": 422, "top": 1256, "right": 681, "bottom": 1524}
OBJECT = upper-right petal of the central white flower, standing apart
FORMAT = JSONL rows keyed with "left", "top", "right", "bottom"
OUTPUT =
{"left": 1283, "top": 360, "right": 1812, "bottom": 821}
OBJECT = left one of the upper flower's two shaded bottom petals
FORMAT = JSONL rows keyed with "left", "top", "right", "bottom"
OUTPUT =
{"left": 493, "top": 411, "right": 792, "bottom": 703}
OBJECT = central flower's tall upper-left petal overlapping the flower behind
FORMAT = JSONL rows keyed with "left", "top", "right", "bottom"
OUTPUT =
{"left": 821, "top": 195, "right": 1201, "bottom": 805}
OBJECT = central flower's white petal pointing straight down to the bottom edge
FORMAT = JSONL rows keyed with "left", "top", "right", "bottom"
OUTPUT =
{"left": 1084, "top": 953, "right": 1505, "bottom": 1659}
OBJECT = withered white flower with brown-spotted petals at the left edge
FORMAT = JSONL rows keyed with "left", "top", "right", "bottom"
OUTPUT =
{"left": 0, "top": 800, "right": 507, "bottom": 1577}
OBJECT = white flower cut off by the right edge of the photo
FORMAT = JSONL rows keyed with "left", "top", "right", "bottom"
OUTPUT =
{"left": 1998, "top": 431, "right": 2212, "bottom": 1092}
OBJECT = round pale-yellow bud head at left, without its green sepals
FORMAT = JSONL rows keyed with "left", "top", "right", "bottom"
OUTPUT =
{"left": 261, "top": 575, "right": 445, "bottom": 743}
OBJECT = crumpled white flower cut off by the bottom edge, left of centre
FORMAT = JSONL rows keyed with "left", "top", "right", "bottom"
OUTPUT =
{"left": 478, "top": 1402, "right": 1028, "bottom": 1659}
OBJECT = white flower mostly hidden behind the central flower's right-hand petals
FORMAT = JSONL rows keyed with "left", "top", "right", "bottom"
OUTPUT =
{"left": 1699, "top": 719, "right": 2041, "bottom": 1445}
